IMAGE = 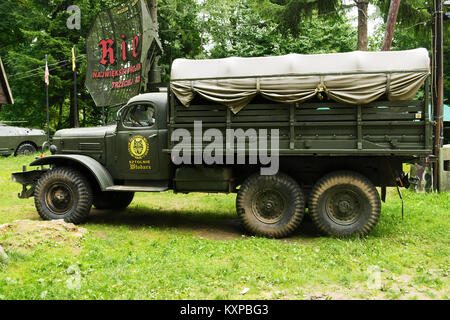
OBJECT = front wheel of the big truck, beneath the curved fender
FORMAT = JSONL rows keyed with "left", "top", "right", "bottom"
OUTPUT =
{"left": 34, "top": 167, "right": 92, "bottom": 223}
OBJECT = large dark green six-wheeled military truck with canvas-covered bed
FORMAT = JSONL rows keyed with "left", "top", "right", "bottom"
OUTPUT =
{"left": 12, "top": 49, "right": 433, "bottom": 238}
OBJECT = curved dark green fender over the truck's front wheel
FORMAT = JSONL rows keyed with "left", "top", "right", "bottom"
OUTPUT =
{"left": 30, "top": 154, "right": 114, "bottom": 191}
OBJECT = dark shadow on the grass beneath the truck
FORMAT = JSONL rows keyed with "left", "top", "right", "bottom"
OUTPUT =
{"left": 87, "top": 208, "right": 318, "bottom": 240}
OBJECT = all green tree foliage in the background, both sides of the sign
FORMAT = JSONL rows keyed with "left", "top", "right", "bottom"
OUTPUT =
{"left": 0, "top": 0, "right": 450, "bottom": 131}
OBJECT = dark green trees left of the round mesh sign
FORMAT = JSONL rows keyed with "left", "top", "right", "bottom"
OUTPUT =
{"left": 0, "top": 0, "right": 112, "bottom": 131}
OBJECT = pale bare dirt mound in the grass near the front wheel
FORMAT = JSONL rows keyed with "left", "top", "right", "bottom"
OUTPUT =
{"left": 0, "top": 220, "right": 87, "bottom": 249}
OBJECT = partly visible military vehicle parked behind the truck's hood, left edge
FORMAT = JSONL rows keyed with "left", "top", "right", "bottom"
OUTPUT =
{"left": 0, "top": 122, "right": 47, "bottom": 156}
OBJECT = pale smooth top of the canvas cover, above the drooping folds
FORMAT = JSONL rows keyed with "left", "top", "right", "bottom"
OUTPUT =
{"left": 171, "top": 48, "right": 430, "bottom": 81}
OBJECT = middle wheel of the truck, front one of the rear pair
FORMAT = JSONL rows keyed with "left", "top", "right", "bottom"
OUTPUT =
{"left": 236, "top": 173, "right": 305, "bottom": 238}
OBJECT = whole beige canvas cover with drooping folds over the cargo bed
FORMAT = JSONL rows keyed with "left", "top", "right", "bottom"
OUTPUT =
{"left": 171, "top": 48, "right": 430, "bottom": 113}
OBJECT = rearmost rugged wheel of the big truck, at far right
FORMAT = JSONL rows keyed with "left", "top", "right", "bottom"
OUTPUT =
{"left": 309, "top": 171, "right": 381, "bottom": 238}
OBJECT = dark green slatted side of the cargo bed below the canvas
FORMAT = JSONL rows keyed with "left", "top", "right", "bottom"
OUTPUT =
{"left": 167, "top": 81, "right": 432, "bottom": 156}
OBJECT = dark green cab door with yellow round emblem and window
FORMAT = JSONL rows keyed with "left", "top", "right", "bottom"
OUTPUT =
{"left": 114, "top": 102, "right": 160, "bottom": 181}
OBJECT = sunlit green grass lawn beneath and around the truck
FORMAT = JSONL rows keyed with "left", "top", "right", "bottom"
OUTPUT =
{"left": 0, "top": 156, "right": 450, "bottom": 299}
